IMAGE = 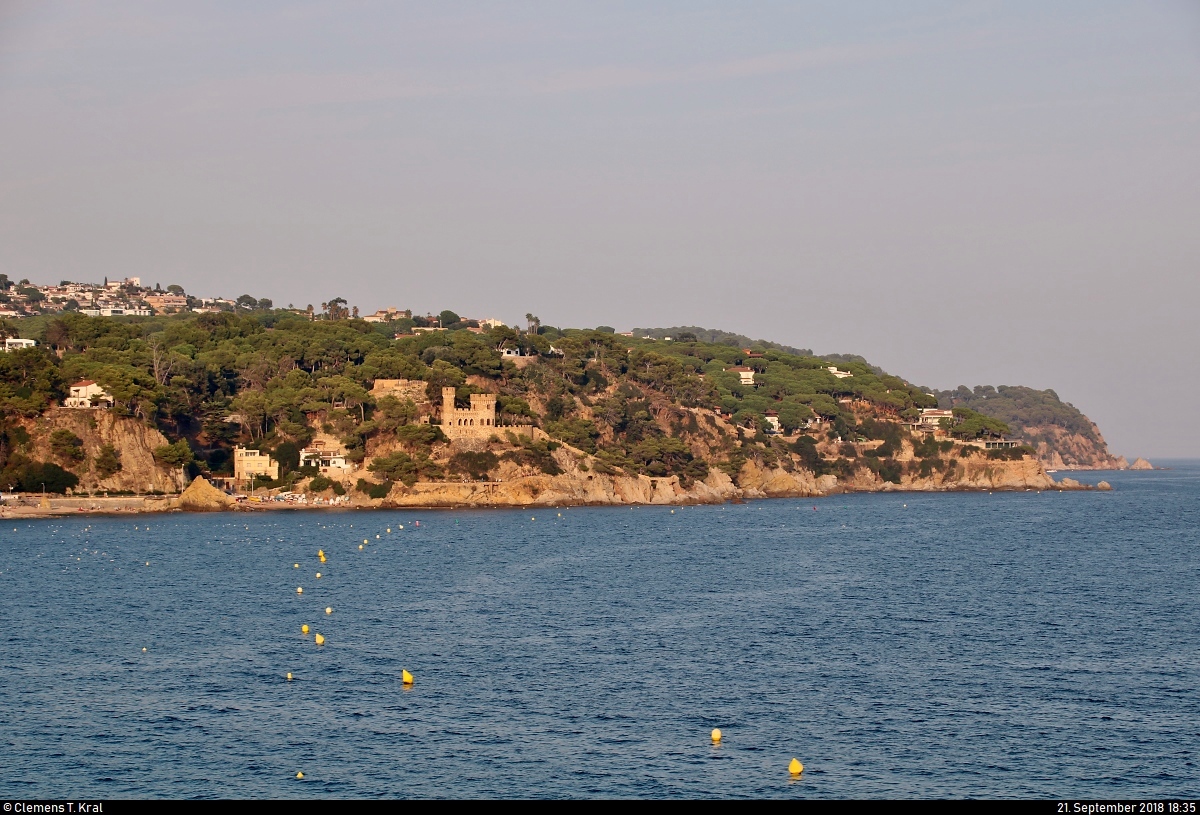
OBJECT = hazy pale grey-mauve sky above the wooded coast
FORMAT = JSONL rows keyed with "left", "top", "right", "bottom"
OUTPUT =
{"left": 0, "top": 0, "right": 1200, "bottom": 456}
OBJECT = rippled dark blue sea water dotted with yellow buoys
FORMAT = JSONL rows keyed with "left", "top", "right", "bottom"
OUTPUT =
{"left": 0, "top": 462, "right": 1200, "bottom": 799}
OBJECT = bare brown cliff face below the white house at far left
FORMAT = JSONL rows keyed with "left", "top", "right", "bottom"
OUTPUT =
{"left": 22, "top": 408, "right": 182, "bottom": 492}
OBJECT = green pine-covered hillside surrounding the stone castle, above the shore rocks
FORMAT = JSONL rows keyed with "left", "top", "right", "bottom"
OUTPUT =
{"left": 0, "top": 310, "right": 1104, "bottom": 489}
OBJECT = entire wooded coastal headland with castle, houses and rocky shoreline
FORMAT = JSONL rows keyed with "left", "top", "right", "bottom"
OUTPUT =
{"left": 0, "top": 275, "right": 1150, "bottom": 514}
